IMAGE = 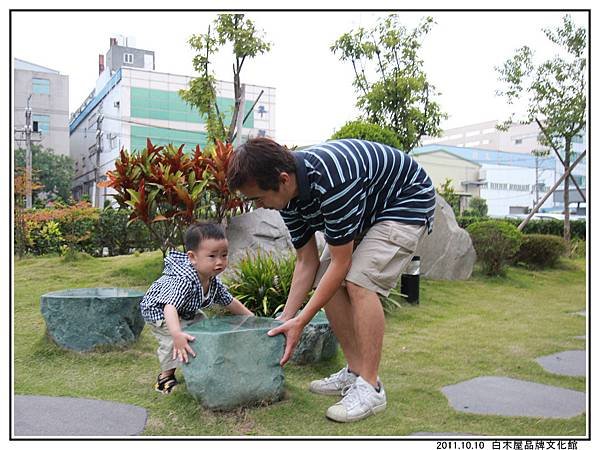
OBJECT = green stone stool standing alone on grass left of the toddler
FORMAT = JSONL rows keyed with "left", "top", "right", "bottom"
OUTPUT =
{"left": 40, "top": 287, "right": 144, "bottom": 351}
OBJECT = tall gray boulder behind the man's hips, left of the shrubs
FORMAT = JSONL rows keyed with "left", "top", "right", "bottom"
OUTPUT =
{"left": 415, "top": 194, "right": 477, "bottom": 280}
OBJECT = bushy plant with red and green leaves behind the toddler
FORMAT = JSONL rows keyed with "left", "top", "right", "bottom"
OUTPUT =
{"left": 101, "top": 139, "right": 245, "bottom": 255}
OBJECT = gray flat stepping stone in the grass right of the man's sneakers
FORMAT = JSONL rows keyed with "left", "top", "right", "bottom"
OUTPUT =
{"left": 442, "top": 377, "right": 585, "bottom": 418}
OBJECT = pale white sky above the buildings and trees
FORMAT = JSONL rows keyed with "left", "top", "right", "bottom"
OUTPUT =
{"left": 12, "top": 11, "right": 587, "bottom": 145}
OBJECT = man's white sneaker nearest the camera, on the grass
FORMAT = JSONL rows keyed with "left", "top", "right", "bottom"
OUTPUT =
{"left": 326, "top": 377, "right": 387, "bottom": 422}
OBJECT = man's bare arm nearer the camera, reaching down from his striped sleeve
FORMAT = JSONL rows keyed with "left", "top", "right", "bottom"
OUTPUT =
{"left": 268, "top": 241, "right": 354, "bottom": 366}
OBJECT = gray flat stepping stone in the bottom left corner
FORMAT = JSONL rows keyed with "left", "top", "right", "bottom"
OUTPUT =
{"left": 14, "top": 395, "right": 147, "bottom": 436}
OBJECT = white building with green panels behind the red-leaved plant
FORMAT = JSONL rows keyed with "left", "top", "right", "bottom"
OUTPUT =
{"left": 69, "top": 39, "right": 275, "bottom": 206}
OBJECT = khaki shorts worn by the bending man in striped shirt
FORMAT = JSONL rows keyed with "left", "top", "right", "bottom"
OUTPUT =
{"left": 313, "top": 220, "right": 427, "bottom": 297}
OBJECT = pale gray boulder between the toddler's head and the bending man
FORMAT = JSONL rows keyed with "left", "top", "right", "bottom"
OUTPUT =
{"left": 227, "top": 208, "right": 294, "bottom": 267}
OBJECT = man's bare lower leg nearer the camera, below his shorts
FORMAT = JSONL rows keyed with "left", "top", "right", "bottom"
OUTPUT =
{"left": 342, "top": 282, "right": 385, "bottom": 388}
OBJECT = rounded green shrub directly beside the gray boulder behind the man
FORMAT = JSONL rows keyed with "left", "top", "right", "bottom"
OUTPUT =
{"left": 467, "top": 220, "right": 522, "bottom": 275}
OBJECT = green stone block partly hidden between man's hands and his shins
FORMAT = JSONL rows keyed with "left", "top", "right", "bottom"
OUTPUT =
{"left": 291, "top": 311, "right": 338, "bottom": 364}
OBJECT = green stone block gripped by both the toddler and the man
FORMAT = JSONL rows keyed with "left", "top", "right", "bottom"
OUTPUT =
{"left": 183, "top": 316, "right": 285, "bottom": 410}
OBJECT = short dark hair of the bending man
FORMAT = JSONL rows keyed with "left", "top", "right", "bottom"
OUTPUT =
{"left": 227, "top": 137, "right": 296, "bottom": 192}
